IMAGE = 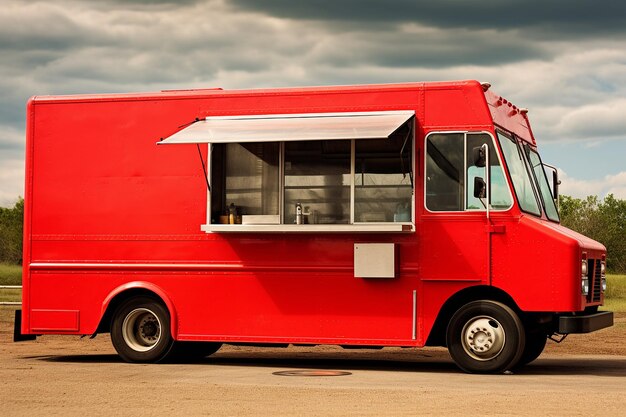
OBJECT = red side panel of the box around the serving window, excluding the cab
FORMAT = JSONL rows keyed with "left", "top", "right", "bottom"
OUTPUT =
{"left": 25, "top": 85, "right": 434, "bottom": 345}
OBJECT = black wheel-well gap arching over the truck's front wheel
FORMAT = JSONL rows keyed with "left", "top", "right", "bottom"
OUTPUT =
{"left": 426, "top": 285, "right": 523, "bottom": 346}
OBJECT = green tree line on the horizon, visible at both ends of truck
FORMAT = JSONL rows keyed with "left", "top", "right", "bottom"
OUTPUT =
{"left": 0, "top": 194, "right": 626, "bottom": 273}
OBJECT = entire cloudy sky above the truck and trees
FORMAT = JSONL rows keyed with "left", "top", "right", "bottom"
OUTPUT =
{"left": 0, "top": 0, "right": 626, "bottom": 206}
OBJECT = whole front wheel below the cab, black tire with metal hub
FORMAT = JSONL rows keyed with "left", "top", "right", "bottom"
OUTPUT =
{"left": 446, "top": 300, "right": 525, "bottom": 373}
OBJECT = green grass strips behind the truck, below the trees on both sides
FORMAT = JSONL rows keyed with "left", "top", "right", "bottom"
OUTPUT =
{"left": 0, "top": 264, "right": 626, "bottom": 312}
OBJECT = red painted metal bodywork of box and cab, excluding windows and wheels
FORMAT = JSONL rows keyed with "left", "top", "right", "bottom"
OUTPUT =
{"left": 22, "top": 81, "right": 604, "bottom": 346}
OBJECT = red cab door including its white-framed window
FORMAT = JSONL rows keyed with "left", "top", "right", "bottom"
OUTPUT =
{"left": 420, "top": 132, "right": 512, "bottom": 284}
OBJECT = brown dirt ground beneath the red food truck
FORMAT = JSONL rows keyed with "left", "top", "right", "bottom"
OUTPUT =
{"left": 0, "top": 308, "right": 626, "bottom": 416}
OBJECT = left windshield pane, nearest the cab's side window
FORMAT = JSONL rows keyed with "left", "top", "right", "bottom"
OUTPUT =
{"left": 498, "top": 132, "right": 541, "bottom": 216}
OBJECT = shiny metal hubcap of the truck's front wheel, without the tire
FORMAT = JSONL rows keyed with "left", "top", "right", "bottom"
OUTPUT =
{"left": 462, "top": 316, "right": 506, "bottom": 361}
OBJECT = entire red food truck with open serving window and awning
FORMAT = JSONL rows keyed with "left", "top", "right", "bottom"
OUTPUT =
{"left": 15, "top": 81, "right": 613, "bottom": 372}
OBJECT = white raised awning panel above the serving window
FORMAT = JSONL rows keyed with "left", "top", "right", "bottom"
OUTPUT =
{"left": 159, "top": 111, "right": 415, "bottom": 144}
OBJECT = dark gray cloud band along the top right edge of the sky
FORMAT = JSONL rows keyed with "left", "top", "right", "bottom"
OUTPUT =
{"left": 232, "top": 0, "right": 626, "bottom": 36}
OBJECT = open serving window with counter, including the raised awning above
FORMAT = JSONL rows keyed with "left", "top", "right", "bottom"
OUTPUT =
{"left": 161, "top": 111, "right": 414, "bottom": 232}
